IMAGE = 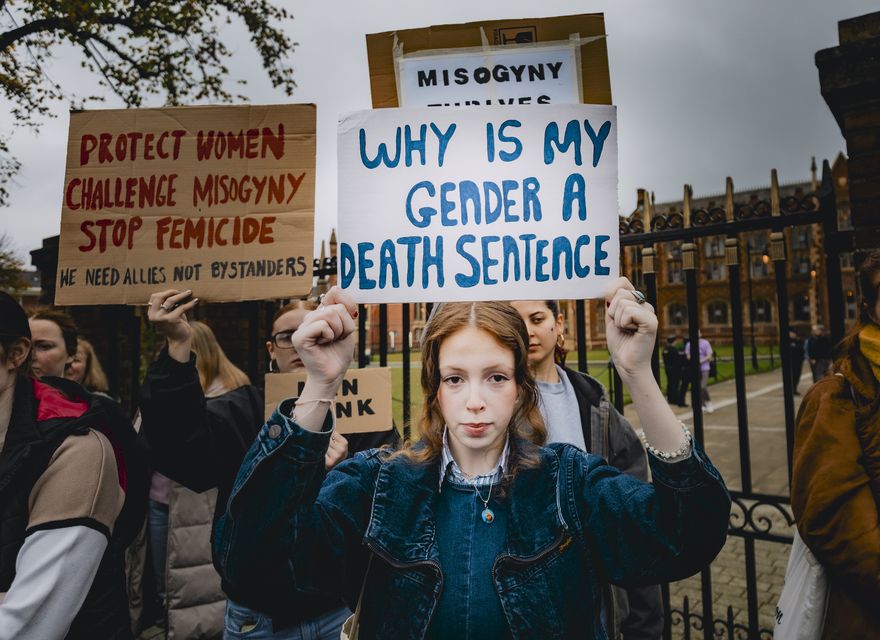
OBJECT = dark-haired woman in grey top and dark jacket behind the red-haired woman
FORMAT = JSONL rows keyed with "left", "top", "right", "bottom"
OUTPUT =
{"left": 510, "top": 300, "right": 664, "bottom": 640}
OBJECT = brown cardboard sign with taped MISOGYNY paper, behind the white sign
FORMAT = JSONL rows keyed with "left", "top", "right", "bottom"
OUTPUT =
{"left": 367, "top": 13, "right": 611, "bottom": 108}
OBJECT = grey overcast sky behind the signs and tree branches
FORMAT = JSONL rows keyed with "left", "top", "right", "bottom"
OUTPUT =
{"left": 0, "top": 0, "right": 877, "bottom": 264}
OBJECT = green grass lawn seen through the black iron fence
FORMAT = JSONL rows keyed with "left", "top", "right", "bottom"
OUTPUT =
{"left": 382, "top": 345, "right": 781, "bottom": 435}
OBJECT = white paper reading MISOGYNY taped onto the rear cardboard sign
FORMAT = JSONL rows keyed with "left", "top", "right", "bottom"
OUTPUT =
{"left": 397, "top": 42, "right": 582, "bottom": 107}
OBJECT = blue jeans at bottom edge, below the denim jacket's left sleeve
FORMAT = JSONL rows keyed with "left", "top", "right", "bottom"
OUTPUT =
{"left": 223, "top": 600, "right": 351, "bottom": 640}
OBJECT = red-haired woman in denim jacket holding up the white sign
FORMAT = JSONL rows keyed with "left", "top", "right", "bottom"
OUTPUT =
{"left": 214, "top": 279, "right": 730, "bottom": 639}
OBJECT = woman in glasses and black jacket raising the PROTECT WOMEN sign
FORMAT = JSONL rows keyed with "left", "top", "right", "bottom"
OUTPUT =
{"left": 141, "top": 290, "right": 399, "bottom": 640}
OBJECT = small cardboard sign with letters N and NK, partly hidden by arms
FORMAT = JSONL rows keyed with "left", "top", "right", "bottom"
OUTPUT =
{"left": 266, "top": 367, "right": 393, "bottom": 435}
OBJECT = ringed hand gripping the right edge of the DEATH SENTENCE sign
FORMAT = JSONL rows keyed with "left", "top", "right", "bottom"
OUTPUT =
{"left": 605, "top": 278, "right": 657, "bottom": 380}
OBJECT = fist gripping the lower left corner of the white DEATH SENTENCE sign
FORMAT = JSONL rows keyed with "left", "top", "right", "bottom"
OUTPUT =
{"left": 292, "top": 287, "right": 357, "bottom": 398}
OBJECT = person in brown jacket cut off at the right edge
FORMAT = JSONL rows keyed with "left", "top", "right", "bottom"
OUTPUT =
{"left": 791, "top": 250, "right": 880, "bottom": 640}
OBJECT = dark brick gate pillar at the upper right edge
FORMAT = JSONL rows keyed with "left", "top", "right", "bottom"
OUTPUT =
{"left": 816, "top": 12, "right": 880, "bottom": 249}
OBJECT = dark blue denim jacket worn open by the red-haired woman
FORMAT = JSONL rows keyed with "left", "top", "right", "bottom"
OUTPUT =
{"left": 214, "top": 401, "right": 730, "bottom": 639}
